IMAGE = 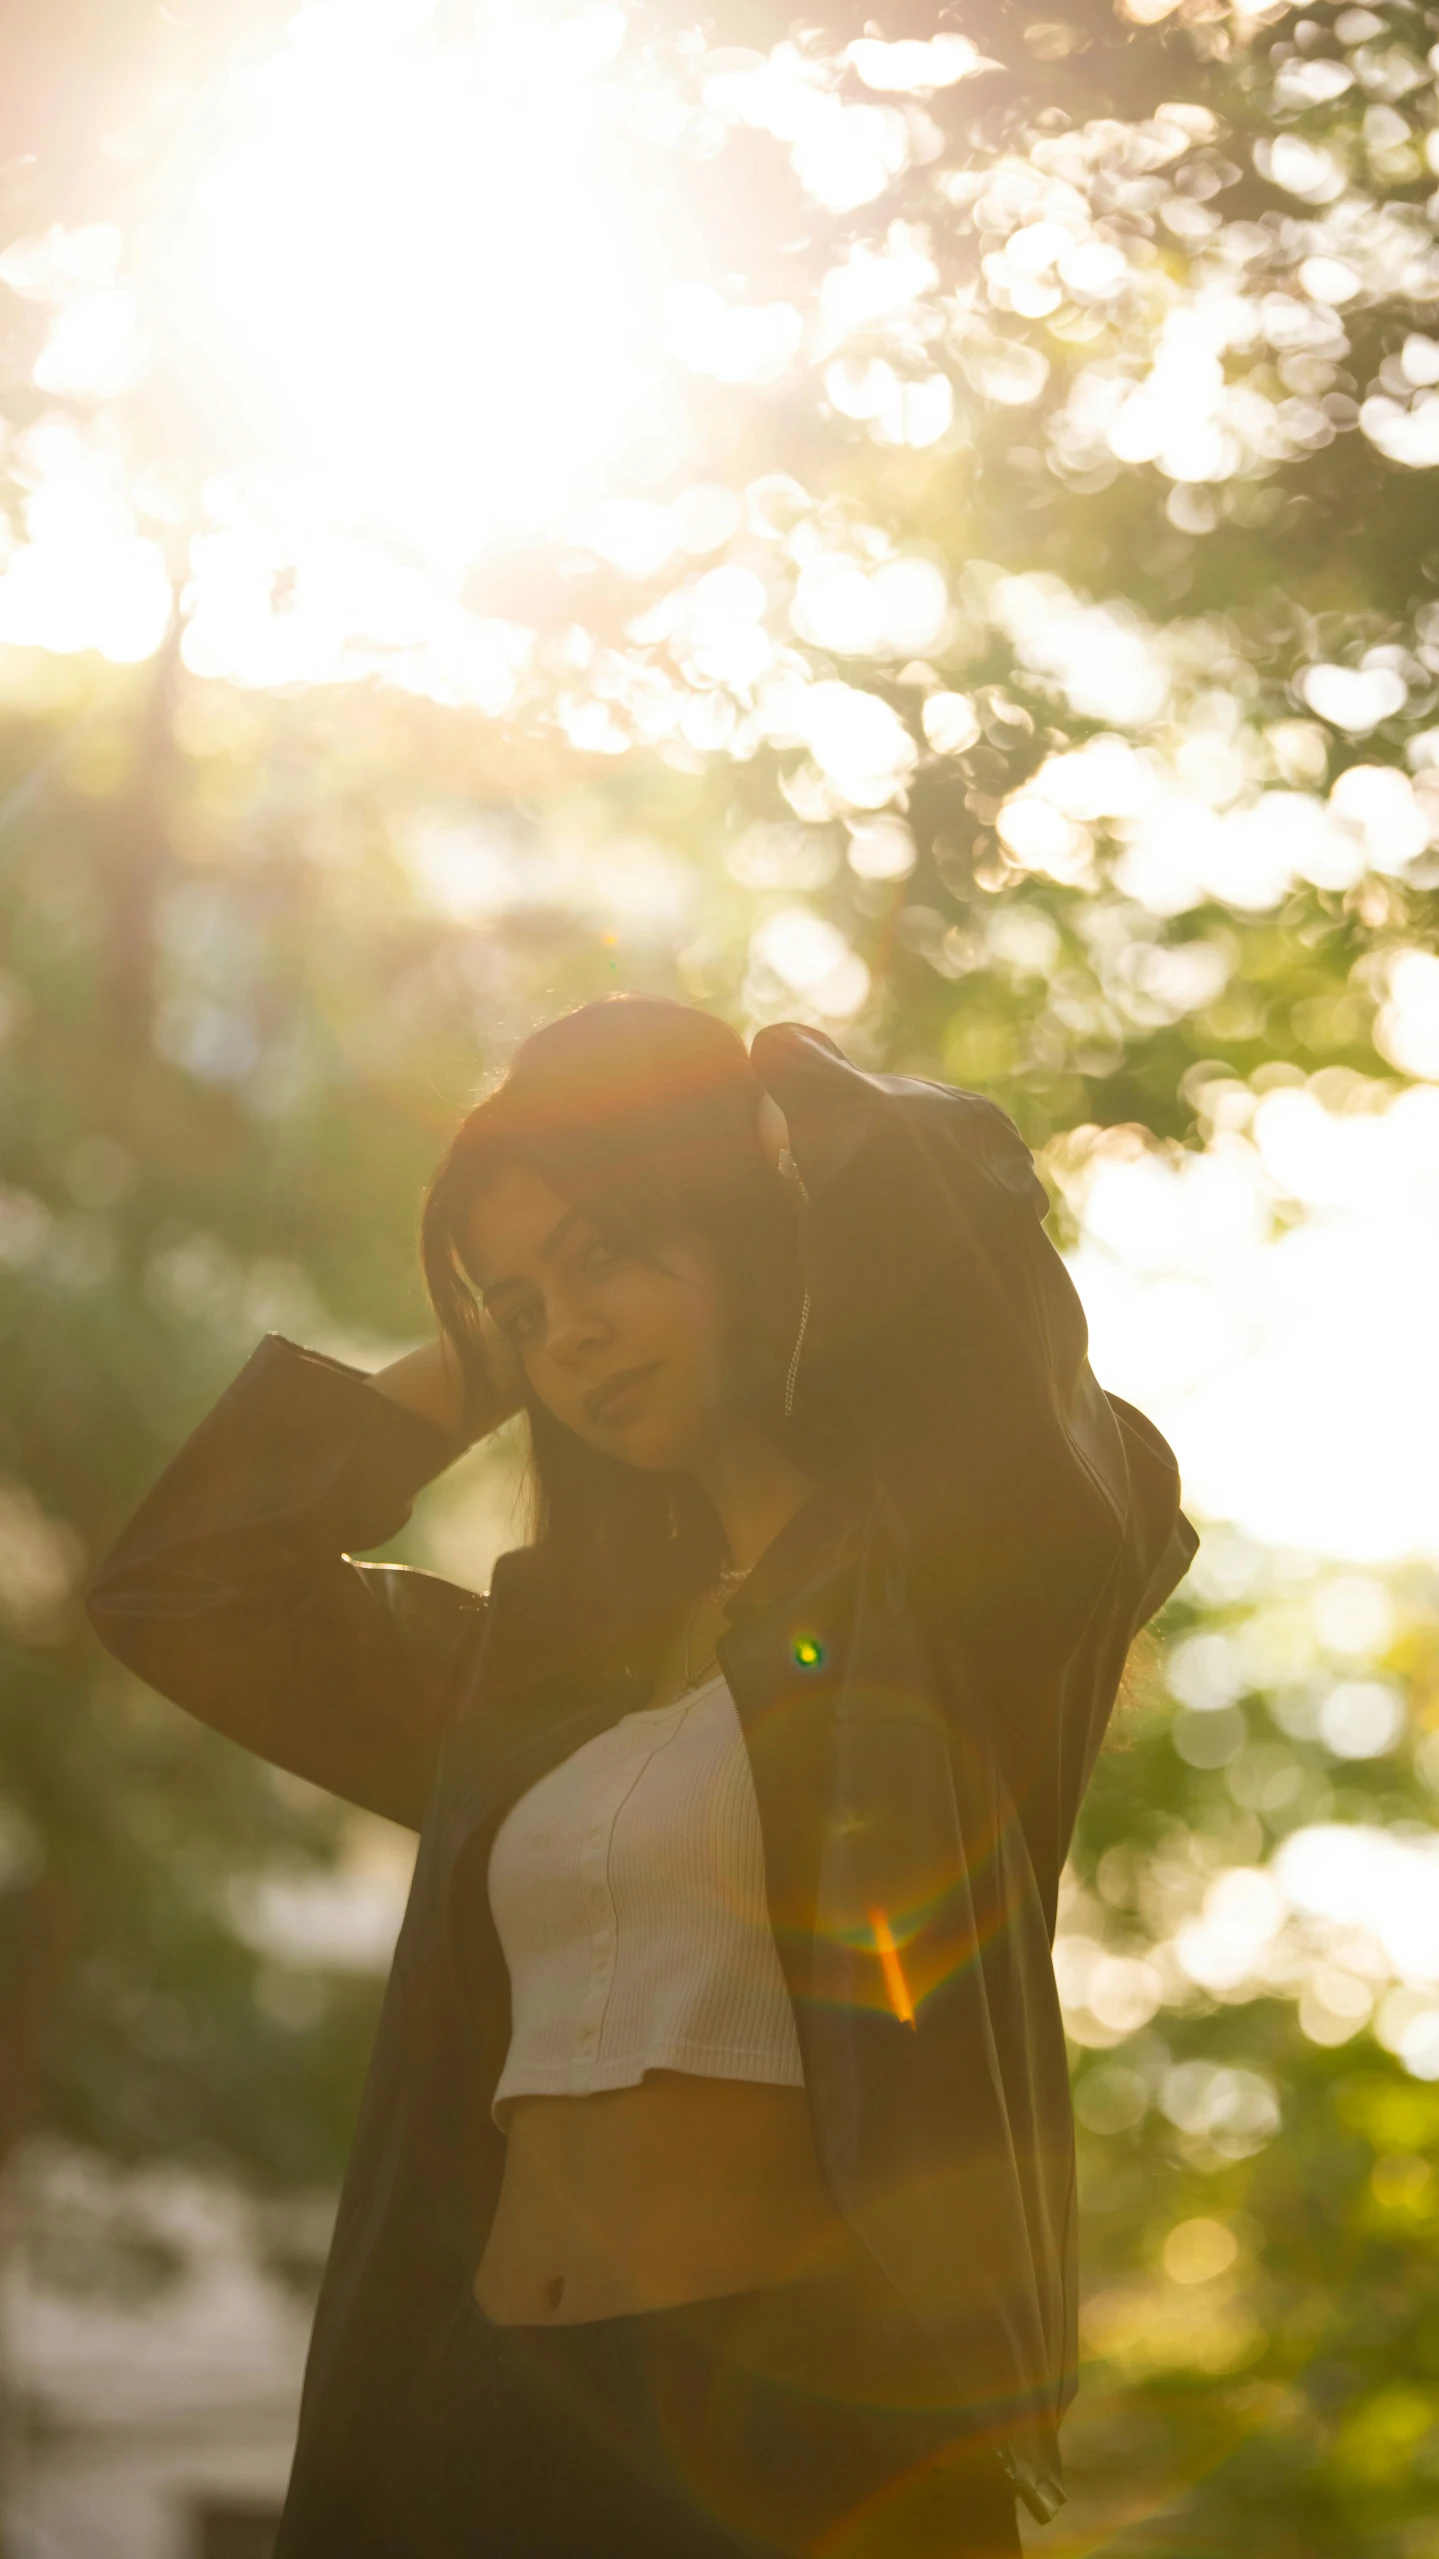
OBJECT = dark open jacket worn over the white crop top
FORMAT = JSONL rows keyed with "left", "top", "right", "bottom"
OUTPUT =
{"left": 92, "top": 1024, "right": 1196, "bottom": 2559}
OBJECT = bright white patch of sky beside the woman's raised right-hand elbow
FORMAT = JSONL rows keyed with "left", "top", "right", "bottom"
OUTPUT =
{"left": 1070, "top": 1080, "right": 1439, "bottom": 1564}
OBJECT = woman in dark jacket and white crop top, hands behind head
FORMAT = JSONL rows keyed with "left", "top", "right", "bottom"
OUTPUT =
{"left": 92, "top": 995, "right": 1196, "bottom": 2559}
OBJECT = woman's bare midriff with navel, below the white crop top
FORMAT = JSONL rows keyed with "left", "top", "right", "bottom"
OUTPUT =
{"left": 474, "top": 2070, "right": 845, "bottom": 2326}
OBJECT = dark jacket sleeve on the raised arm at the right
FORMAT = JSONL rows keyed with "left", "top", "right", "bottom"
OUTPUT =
{"left": 750, "top": 1024, "right": 1196, "bottom": 1686}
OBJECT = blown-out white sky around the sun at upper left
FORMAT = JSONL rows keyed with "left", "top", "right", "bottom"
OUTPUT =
{"left": 0, "top": 0, "right": 978, "bottom": 709}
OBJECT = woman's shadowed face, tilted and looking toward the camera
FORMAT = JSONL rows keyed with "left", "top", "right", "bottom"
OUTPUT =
{"left": 466, "top": 1162, "right": 725, "bottom": 1471}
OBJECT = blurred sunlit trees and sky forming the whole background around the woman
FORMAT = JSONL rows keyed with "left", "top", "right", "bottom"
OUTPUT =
{"left": 0, "top": 0, "right": 1439, "bottom": 2559}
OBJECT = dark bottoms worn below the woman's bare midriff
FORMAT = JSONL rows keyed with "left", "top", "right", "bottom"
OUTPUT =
{"left": 389, "top": 2260, "right": 1019, "bottom": 2559}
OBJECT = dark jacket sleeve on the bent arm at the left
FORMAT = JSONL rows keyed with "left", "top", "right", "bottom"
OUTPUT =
{"left": 90, "top": 1333, "right": 484, "bottom": 1830}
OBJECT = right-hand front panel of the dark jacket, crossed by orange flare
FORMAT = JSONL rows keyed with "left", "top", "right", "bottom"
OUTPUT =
{"left": 720, "top": 1492, "right": 1063, "bottom": 2477}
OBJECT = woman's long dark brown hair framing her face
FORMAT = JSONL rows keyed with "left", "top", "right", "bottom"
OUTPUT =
{"left": 420, "top": 995, "right": 837, "bottom": 1574}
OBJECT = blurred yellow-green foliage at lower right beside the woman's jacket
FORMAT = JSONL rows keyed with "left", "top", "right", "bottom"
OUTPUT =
{"left": 1057, "top": 1545, "right": 1439, "bottom": 2559}
